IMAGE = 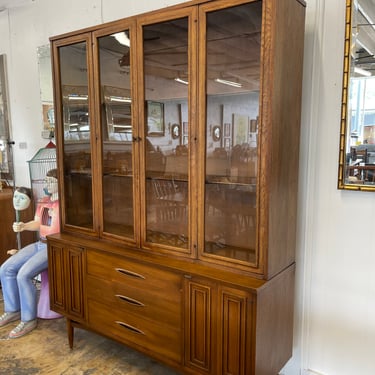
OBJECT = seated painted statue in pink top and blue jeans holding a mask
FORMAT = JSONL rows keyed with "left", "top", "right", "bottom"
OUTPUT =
{"left": 0, "top": 169, "right": 60, "bottom": 339}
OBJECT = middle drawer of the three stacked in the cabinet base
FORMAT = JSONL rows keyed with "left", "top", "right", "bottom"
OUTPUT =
{"left": 86, "top": 276, "right": 182, "bottom": 326}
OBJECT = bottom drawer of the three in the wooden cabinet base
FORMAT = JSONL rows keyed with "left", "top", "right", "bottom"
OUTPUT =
{"left": 88, "top": 300, "right": 182, "bottom": 362}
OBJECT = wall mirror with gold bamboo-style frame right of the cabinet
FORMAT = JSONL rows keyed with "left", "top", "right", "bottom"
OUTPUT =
{"left": 338, "top": 0, "right": 375, "bottom": 191}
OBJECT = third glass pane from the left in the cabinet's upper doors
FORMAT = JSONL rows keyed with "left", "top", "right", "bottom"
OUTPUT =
{"left": 143, "top": 18, "right": 189, "bottom": 253}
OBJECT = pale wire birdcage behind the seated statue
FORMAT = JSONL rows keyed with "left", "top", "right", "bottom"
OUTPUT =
{"left": 28, "top": 141, "right": 57, "bottom": 203}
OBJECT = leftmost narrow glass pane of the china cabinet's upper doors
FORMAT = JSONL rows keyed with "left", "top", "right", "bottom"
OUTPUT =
{"left": 59, "top": 42, "right": 93, "bottom": 228}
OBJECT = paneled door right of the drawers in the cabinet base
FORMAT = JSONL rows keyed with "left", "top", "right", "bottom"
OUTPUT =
{"left": 185, "top": 277, "right": 254, "bottom": 375}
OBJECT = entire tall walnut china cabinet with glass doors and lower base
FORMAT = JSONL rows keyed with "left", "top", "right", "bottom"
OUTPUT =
{"left": 48, "top": 0, "right": 305, "bottom": 375}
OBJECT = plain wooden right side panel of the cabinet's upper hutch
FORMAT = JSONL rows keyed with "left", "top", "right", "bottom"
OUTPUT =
{"left": 267, "top": 0, "right": 305, "bottom": 278}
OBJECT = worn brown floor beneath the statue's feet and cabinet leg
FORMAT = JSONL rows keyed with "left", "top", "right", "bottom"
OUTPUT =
{"left": 0, "top": 294, "right": 177, "bottom": 375}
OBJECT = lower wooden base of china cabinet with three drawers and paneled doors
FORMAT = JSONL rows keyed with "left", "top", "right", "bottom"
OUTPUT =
{"left": 48, "top": 234, "right": 294, "bottom": 375}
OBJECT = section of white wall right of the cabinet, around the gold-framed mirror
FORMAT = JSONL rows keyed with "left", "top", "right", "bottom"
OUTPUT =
{"left": 283, "top": 0, "right": 375, "bottom": 375}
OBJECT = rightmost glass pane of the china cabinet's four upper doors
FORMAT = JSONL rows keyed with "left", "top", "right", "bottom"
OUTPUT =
{"left": 205, "top": 2, "right": 262, "bottom": 262}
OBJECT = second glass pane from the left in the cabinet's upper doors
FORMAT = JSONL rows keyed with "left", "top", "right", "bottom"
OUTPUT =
{"left": 98, "top": 30, "right": 134, "bottom": 238}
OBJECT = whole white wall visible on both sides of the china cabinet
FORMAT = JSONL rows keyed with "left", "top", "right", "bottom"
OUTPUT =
{"left": 0, "top": 0, "right": 375, "bottom": 375}
